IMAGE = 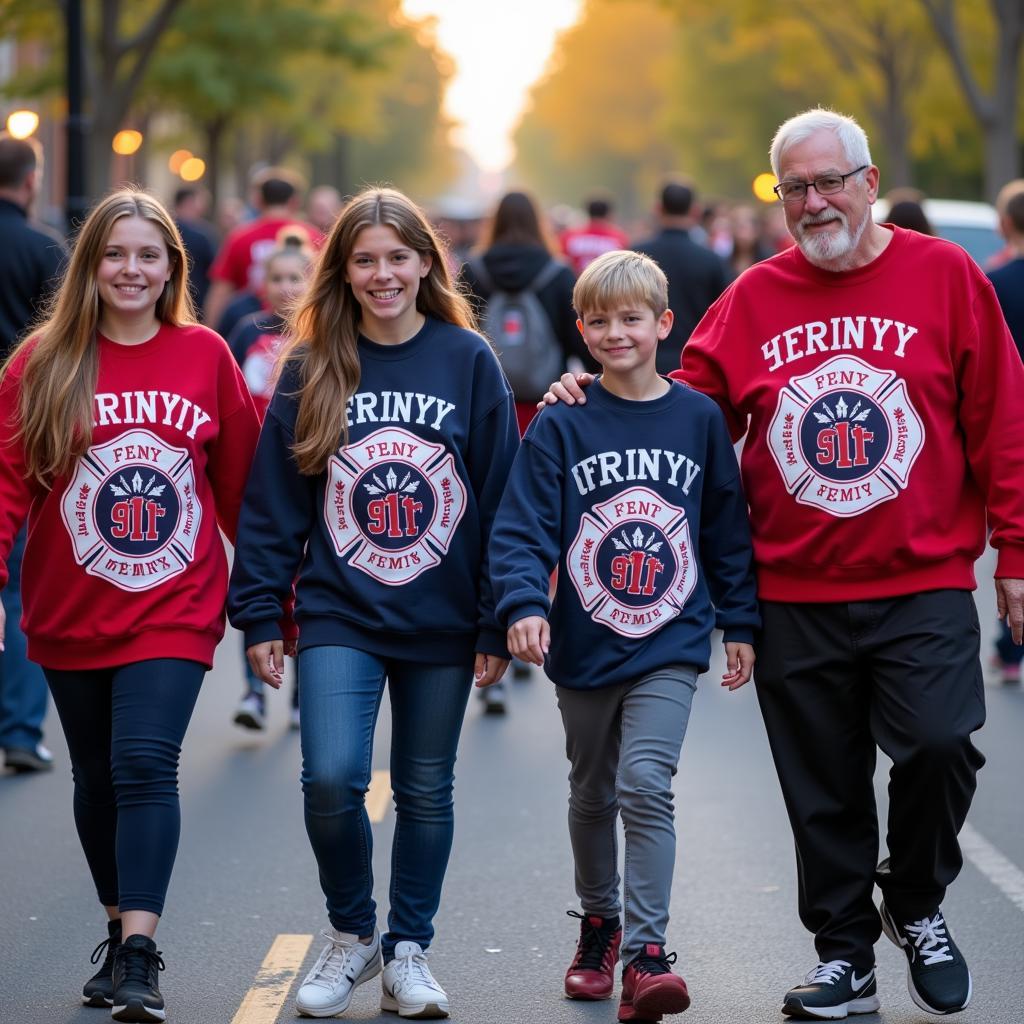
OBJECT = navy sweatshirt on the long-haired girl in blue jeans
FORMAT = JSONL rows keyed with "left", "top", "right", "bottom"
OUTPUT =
{"left": 228, "top": 318, "right": 519, "bottom": 665}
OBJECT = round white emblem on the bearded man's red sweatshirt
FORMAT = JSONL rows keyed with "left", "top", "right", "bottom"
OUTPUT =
{"left": 768, "top": 355, "right": 925, "bottom": 517}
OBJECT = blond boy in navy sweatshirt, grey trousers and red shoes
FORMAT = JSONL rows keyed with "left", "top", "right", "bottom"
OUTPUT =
{"left": 490, "top": 251, "right": 759, "bottom": 1021}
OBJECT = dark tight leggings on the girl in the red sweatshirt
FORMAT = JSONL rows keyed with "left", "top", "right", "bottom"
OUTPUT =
{"left": 44, "top": 658, "right": 206, "bottom": 914}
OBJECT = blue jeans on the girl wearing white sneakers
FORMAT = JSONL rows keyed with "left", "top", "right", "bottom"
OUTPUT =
{"left": 299, "top": 647, "right": 473, "bottom": 961}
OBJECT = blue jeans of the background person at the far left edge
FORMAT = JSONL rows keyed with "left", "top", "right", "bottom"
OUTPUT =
{"left": 0, "top": 526, "right": 46, "bottom": 751}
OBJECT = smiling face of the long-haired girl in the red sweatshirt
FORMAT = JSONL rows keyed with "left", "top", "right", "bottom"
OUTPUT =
{"left": 96, "top": 217, "right": 171, "bottom": 319}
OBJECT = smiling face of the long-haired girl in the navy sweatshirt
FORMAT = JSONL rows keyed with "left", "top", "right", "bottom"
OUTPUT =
{"left": 345, "top": 224, "right": 431, "bottom": 343}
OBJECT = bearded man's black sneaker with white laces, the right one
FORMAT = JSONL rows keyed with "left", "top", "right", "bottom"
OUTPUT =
{"left": 879, "top": 902, "right": 972, "bottom": 1014}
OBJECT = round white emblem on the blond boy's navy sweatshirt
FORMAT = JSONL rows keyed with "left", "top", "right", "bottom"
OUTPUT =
{"left": 565, "top": 487, "right": 696, "bottom": 637}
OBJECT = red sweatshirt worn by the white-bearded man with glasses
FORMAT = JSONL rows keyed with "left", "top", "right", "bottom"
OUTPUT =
{"left": 673, "top": 228, "right": 1024, "bottom": 601}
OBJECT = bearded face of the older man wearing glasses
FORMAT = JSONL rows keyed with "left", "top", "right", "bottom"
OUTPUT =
{"left": 779, "top": 130, "right": 879, "bottom": 270}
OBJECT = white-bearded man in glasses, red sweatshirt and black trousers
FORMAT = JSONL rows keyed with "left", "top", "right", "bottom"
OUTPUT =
{"left": 552, "top": 110, "right": 1024, "bottom": 1020}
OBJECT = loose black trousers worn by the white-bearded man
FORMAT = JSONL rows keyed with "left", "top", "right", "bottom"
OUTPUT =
{"left": 755, "top": 590, "right": 985, "bottom": 967}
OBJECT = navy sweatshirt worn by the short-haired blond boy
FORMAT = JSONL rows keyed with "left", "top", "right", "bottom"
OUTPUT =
{"left": 490, "top": 382, "right": 760, "bottom": 689}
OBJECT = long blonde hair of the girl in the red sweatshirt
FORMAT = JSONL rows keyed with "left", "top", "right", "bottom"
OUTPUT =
{"left": 0, "top": 188, "right": 196, "bottom": 487}
